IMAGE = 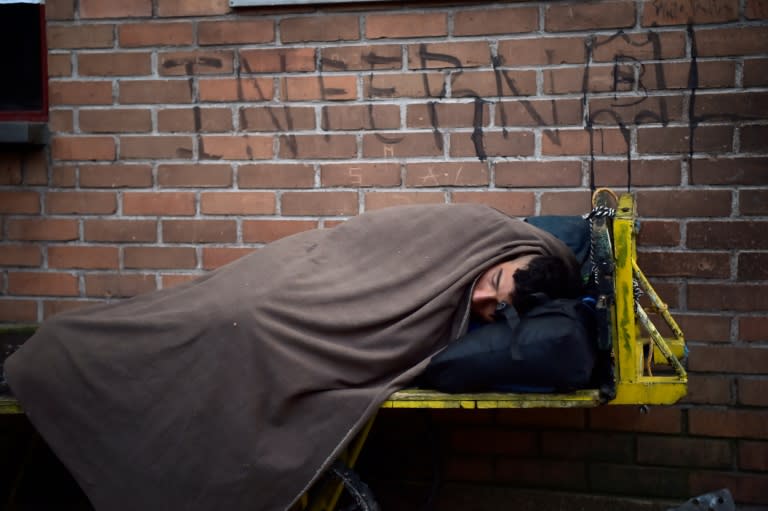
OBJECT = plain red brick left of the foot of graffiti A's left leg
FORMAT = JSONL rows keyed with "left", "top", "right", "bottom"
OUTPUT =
{"left": 494, "top": 161, "right": 582, "bottom": 188}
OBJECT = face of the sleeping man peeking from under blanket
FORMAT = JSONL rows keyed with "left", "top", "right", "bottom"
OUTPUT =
{"left": 472, "top": 255, "right": 536, "bottom": 323}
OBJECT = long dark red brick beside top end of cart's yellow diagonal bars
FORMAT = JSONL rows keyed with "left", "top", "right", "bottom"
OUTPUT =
{"left": 638, "top": 251, "right": 731, "bottom": 279}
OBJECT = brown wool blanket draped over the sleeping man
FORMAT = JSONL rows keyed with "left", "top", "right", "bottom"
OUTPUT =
{"left": 6, "top": 205, "right": 576, "bottom": 511}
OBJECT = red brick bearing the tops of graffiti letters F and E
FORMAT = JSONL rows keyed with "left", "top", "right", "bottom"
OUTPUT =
{"left": 320, "top": 44, "right": 403, "bottom": 71}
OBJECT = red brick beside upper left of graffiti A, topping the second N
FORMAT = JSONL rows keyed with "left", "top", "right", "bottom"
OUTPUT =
{"left": 498, "top": 37, "right": 586, "bottom": 66}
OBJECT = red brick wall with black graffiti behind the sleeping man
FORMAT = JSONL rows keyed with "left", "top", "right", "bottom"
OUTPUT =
{"left": 0, "top": 0, "right": 768, "bottom": 509}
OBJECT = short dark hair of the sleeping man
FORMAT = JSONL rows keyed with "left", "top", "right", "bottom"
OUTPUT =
{"left": 512, "top": 256, "right": 581, "bottom": 313}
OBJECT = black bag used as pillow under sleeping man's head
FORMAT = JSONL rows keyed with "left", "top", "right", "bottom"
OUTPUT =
{"left": 414, "top": 295, "right": 596, "bottom": 393}
